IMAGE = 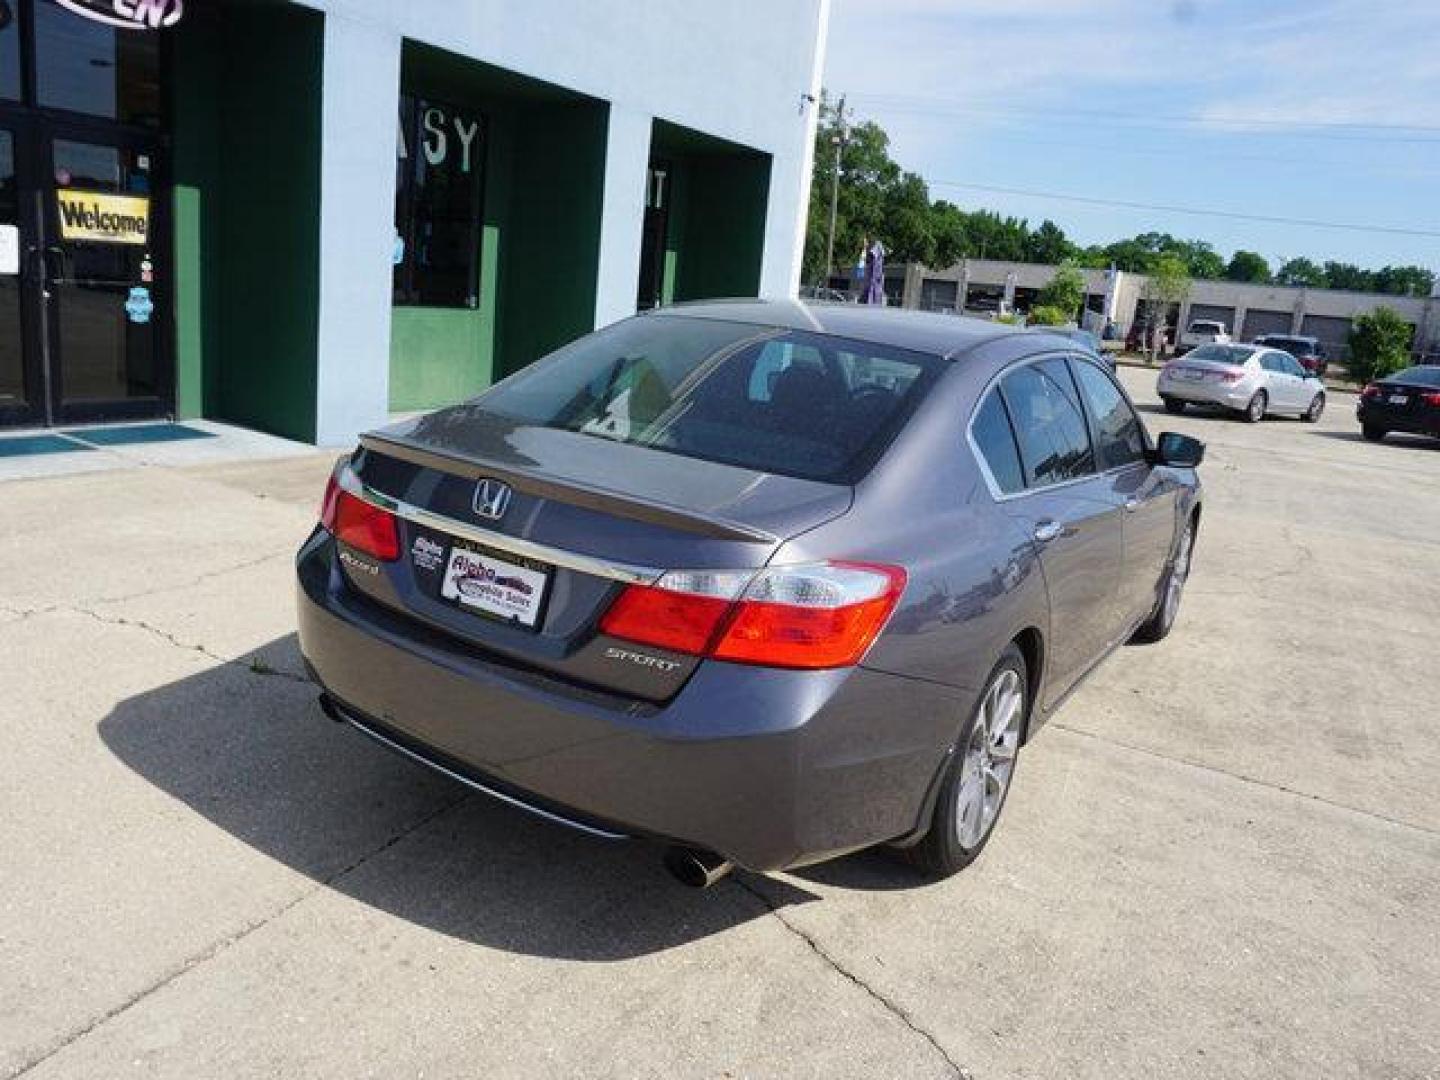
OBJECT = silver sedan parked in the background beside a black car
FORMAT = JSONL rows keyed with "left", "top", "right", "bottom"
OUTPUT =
{"left": 1156, "top": 341, "right": 1325, "bottom": 423}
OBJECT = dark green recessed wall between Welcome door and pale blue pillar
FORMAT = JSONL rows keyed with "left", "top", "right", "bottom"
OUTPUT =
{"left": 173, "top": 4, "right": 324, "bottom": 441}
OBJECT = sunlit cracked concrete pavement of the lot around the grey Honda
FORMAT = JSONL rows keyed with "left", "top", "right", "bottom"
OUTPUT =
{"left": 0, "top": 370, "right": 1440, "bottom": 1080}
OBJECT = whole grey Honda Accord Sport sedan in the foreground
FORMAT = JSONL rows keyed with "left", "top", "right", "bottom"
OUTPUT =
{"left": 297, "top": 301, "right": 1204, "bottom": 884}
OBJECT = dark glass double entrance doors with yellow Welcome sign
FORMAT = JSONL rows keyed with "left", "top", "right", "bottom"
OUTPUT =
{"left": 0, "top": 114, "right": 171, "bottom": 425}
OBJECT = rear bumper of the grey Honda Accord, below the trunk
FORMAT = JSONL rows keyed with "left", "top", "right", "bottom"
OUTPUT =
{"left": 297, "top": 531, "right": 972, "bottom": 870}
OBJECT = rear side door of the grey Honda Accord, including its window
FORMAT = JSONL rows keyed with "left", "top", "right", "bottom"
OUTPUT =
{"left": 998, "top": 356, "right": 1125, "bottom": 707}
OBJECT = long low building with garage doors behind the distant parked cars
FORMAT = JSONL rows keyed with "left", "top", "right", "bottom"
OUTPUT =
{"left": 887, "top": 259, "right": 1440, "bottom": 363}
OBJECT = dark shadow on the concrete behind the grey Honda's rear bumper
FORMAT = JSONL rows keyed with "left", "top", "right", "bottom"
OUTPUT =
{"left": 99, "top": 635, "right": 816, "bottom": 960}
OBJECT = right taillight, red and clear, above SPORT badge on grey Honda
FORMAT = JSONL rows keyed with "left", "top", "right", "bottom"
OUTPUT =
{"left": 600, "top": 563, "right": 906, "bottom": 668}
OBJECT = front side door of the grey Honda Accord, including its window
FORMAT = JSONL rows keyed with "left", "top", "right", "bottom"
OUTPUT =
{"left": 1070, "top": 357, "right": 1181, "bottom": 631}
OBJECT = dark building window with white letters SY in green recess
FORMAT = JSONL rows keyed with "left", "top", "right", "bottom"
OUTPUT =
{"left": 395, "top": 94, "right": 485, "bottom": 308}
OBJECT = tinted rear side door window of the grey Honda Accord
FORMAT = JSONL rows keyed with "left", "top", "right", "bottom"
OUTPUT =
{"left": 1001, "top": 361, "right": 1094, "bottom": 487}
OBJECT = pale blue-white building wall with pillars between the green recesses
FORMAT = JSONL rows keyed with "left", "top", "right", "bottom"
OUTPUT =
{"left": 301, "top": 0, "right": 829, "bottom": 444}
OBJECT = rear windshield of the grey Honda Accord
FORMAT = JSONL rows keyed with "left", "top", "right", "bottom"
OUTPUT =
{"left": 478, "top": 315, "right": 945, "bottom": 484}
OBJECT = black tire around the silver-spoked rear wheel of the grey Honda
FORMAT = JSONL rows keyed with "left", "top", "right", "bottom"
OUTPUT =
{"left": 900, "top": 644, "right": 1030, "bottom": 877}
